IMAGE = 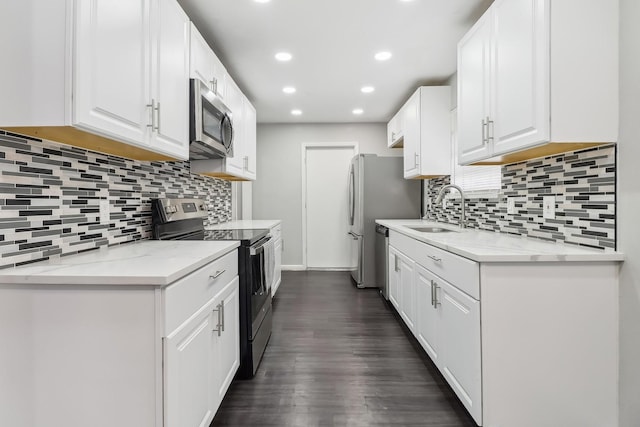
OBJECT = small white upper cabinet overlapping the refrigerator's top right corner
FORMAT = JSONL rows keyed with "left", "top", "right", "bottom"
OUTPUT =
{"left": 400, "top": 86, "right": 451, "bottom": 179}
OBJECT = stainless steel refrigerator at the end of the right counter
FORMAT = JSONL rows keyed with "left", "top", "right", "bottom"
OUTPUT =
{"left": 348, "top": 154, "right": 421, "bottom": 289}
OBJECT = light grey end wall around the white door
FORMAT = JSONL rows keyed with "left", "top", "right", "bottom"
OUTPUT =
{"left": 252, "top": 123, "right": 402, "bottom": 266}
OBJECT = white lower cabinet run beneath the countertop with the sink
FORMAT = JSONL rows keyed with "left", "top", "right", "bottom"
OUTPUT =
{"left": 388, "top": 230, "right": 619, "bottom": 427}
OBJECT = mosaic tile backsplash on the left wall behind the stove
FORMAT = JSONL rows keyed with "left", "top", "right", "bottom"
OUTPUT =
{"left": 0, "top": 131, "right": 231, "bottom": 268}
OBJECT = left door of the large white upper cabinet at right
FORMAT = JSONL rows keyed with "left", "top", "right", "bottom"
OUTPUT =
{"left": 458, "top": 9, "right": 493, "bottom": 164}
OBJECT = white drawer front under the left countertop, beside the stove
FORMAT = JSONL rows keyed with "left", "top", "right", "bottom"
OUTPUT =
{"left": 163, "top": 250, "right": 238, "bottom": 335}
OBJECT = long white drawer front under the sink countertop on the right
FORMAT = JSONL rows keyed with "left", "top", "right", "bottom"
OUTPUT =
{"left": 389, "top": 230, "right": 480, "bottom": 300}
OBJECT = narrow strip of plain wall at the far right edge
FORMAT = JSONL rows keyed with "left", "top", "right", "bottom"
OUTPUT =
{"left": 618, "top": 0, "right": 640, "bottom": 427}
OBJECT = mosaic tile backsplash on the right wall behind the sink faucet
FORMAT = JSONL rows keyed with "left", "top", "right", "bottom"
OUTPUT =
{"left": 425, "top": 146, "right": 616, "bottom": 250}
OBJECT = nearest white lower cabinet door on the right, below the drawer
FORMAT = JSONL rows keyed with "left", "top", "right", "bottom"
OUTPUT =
{"left": 434, "top": 279, "right": 482, "bottom": 423}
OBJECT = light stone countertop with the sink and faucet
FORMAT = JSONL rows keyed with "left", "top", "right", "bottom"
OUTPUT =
{"left": 376, "top": 219, "right": 624, "bottom": 262}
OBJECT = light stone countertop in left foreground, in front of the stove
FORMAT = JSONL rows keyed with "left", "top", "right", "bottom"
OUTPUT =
{"left": 0, "top": 240, "right": 239, "bottom": 286}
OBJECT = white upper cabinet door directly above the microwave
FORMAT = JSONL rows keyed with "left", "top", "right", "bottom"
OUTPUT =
{"left": 190, "top": 24, "right": 227, "bottom": 99}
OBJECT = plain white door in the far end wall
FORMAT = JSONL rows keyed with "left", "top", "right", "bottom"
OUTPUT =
{"left": 303, "top": 143, "right": 357, "bottom": 269}
